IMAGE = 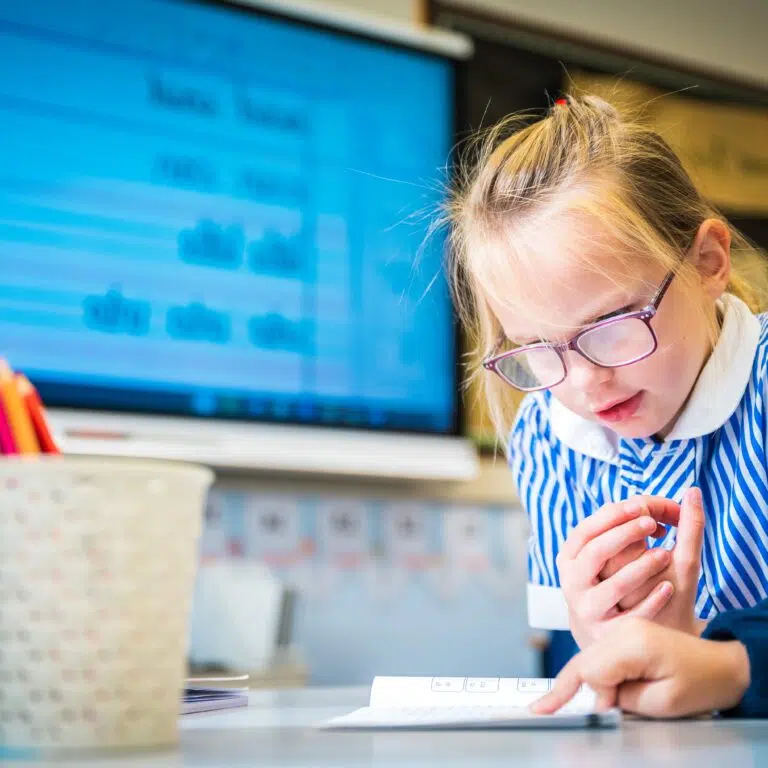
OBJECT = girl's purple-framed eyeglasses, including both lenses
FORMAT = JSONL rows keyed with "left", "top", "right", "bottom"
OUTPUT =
{"left": 483, "top": 272, "right": 675, "bottom": 392}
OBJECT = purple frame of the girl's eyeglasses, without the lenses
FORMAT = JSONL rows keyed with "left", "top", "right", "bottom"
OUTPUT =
{"left": 483, "top": 272, "right": 675, "bottom": 392}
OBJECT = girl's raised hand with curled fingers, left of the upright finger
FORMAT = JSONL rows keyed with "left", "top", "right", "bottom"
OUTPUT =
{"left": 557, "top": 496, "right": 679, "bottom": 648}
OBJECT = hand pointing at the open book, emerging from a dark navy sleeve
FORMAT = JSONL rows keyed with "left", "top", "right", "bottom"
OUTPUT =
{"left": 531, "top": 618, "right": 750, "bottom": 717}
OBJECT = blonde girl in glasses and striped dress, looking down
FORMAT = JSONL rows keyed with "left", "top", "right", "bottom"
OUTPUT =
{"left": 449, "top": 97, "right": 768, "bottom": 646}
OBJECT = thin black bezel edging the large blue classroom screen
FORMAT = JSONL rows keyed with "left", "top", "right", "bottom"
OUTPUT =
{"left": 16, "top": 0, "right": 471, "bottom": 437}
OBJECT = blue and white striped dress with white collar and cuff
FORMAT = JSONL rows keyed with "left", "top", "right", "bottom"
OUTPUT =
{"left": 509, "top": 295, "right": 768, "bottom": 629}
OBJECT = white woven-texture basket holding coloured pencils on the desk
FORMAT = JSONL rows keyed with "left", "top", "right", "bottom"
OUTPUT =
{"left": 0, "top": 456, "right": 213, "bottom": 758}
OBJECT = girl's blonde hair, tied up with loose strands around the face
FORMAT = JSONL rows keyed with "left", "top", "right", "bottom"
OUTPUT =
{"left": 446, "top": 96, "right": 764, "bottom": 443}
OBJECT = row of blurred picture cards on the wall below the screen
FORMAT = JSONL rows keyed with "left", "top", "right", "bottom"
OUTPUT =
{"left": 201, "top": 490, "right": 525, "bottom": 600}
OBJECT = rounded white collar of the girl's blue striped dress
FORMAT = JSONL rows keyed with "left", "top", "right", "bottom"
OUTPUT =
{"left": 550, "top": 294, "right": 760, "bottom": 463}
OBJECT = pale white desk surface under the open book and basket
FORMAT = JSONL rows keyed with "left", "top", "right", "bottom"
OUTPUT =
{"left": 15, "top": 688, "right": 768, "bottom": 768}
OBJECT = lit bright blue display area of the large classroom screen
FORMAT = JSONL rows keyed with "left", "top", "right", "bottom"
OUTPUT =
{"left": 0, "top": 0, "right": 456, "bottom": 433}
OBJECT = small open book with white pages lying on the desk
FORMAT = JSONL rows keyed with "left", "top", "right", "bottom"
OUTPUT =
{"left": 321, "top": 677, "right": 621, "bottom": 730}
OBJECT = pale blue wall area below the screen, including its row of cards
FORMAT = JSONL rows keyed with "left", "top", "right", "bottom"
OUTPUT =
{"left": 196, "top": 488, "right": 538, "bottom": 684}
